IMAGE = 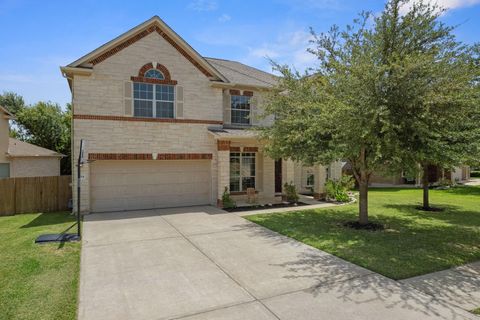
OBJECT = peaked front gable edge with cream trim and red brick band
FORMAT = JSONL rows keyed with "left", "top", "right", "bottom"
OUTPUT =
{"left": 67, "top": 16, "right": 228, "bottom": 82}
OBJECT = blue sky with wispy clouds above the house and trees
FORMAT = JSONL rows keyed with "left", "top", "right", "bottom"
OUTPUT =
{"left": 0, "top": 0, "right": 480, "bottom": 105}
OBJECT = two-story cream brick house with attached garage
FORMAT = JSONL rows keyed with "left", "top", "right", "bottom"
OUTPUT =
{"left": 61, "top": 16, "right": 341, "bottom": 212}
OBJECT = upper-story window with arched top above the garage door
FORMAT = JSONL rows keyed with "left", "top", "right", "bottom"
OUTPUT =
{"left": 133, "top": 69, "right": 175, "bottom": 118}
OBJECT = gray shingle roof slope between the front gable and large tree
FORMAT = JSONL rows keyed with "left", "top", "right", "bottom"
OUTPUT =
{"left": 205, "top": 58, "right": 277, "bottom": 87}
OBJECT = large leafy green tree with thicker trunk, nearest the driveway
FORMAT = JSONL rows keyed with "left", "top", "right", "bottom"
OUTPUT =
{"left": 261, "top": 0, "right": 480, "bottom": 224}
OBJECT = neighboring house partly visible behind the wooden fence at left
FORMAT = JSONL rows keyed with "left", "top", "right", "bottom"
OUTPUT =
{"left": 0, "top": 107, "right": 63, "bottom": 178}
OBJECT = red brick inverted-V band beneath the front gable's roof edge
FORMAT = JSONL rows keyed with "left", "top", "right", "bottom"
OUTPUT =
{"left": 89, "top": 24, "right": 212, "bottom": 77}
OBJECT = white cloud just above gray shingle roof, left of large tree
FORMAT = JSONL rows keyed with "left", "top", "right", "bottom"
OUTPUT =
{"left": 241, "top": 30, "right": 317, "bottom": 72}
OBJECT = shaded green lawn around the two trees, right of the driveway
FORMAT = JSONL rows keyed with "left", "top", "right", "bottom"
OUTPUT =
{"left": 247, "top": 187, "right": 480, "bottom": 279}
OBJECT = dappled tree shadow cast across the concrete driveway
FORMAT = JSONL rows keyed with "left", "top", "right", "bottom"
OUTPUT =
{"left": 234, "top": 220, "right": 474, "bottom": 319}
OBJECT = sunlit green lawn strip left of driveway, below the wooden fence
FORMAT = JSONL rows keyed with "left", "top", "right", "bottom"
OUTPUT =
{"left": 0, "top": 213, "right": 80, "bottom": 320}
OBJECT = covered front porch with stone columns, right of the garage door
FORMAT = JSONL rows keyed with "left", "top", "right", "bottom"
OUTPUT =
{"left": 209, "top": 128, "right": 334, "bottom": 207}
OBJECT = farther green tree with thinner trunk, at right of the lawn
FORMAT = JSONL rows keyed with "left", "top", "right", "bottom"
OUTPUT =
{"left": 377, "top": 0, "right": 480, "bottom": 210}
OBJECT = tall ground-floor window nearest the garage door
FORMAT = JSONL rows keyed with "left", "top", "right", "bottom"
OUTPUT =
{"left": 230, "top": 152, "right": 255, "bottom": 192}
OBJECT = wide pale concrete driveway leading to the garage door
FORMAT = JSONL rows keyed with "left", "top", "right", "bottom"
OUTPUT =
{"left": 79, "top": 207, "right": 476, "bottom": 320}
